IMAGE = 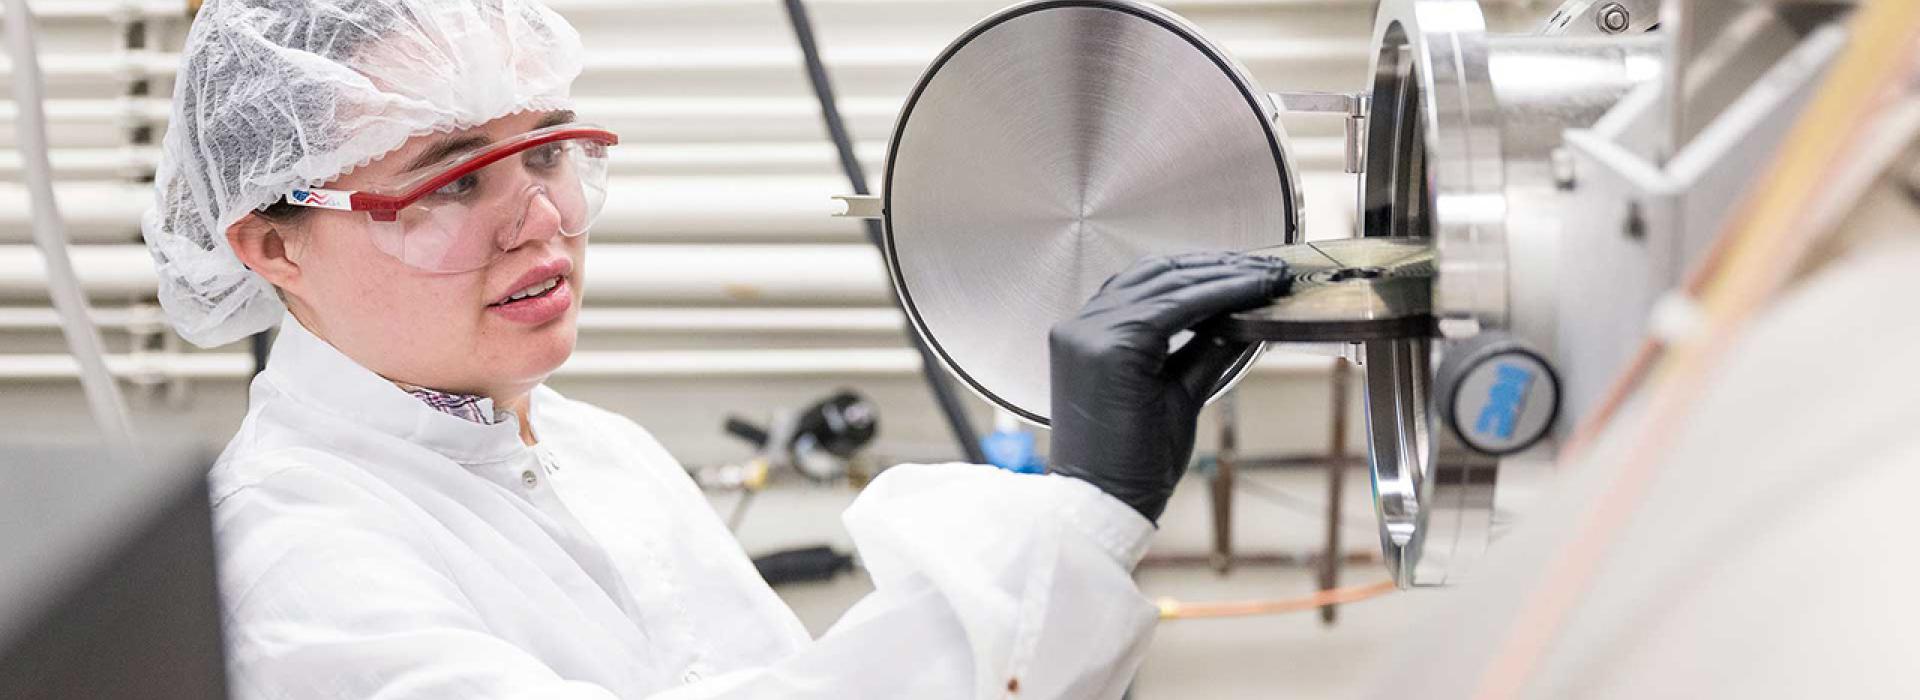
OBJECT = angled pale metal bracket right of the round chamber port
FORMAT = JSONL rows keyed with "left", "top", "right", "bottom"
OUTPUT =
{"left": 1540, "top": 0, "right": 1851, "bottom": 431}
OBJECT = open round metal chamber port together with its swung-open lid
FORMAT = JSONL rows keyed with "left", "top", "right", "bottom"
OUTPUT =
{"left": 883, "top": 0, "right": 1661, "bottom": 587}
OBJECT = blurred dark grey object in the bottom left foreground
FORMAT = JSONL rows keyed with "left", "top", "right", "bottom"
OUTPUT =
{"left": 0, "top": 445, "right": 227, "bottom": 700}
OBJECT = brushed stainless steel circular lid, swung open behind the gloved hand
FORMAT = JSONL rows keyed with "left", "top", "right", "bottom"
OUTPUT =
{"left": 885, "top": 0, "right": 1300, "bottom": 424}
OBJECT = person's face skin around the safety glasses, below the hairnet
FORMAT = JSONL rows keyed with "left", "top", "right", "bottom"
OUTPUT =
{"left": 282, "top": 113, "right": 586, "bottom": 397}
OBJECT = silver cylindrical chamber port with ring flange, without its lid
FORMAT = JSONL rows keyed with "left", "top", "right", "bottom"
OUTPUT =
{"left": 1359, "top": 0, "right": 1661, "bottom": 587}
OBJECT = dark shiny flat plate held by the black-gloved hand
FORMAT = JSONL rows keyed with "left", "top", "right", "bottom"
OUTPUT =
{"left": 1208, "top": 238, "right": 1434, "bottom": 343}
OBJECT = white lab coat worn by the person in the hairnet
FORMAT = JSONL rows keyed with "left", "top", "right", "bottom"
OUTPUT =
{"left": 213, "top": 318, "right": 1156, "bottom": 698}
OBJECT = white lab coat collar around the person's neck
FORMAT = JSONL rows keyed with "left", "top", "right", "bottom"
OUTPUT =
{"left": 261, "top": 315, "right": 540, "bottom": 464}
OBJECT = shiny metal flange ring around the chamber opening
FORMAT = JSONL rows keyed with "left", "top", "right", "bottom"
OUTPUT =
{"left": 1361, "top": 0, "right": 1507, "bottom": 587}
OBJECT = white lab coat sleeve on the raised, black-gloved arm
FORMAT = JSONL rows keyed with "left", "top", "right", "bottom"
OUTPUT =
{"left": 664, "top": 464, "right": 1156, "bottom": 698}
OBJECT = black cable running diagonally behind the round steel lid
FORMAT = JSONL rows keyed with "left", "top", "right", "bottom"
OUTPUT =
{"left": 785, "top": 0, "right": 987, "bottom": 464}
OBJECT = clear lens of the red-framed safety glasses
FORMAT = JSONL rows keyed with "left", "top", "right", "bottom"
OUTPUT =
{"left": 372, "top": 138, "right": 607, "bottom": 272}
